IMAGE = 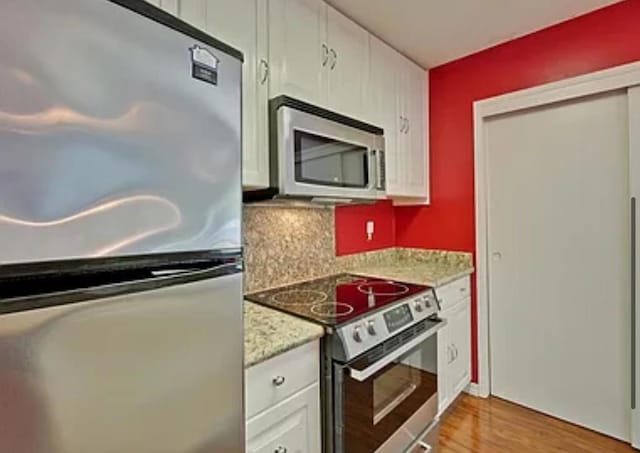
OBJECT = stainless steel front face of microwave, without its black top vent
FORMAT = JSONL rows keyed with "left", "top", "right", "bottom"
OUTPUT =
{"left": 278, "top": 107, "right": 384, "bottom": 200}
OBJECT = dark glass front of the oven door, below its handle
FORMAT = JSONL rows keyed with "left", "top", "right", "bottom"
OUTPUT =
{"left": 336, "top": 324, "right": 438, "bottom": 453}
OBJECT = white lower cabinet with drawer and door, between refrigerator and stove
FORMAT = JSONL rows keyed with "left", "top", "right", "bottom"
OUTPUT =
{"left": 246, "top": 341, "right": 322, "bottom": 453}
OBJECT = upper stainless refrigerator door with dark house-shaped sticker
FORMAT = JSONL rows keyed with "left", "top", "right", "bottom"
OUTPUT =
{"left": 0, "top": 0, "right": 242, "bottom": 264}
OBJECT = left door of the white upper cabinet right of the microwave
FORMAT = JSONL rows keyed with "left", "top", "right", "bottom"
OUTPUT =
{"left": 366, "top": 35, "right": 399, "bottom": 195}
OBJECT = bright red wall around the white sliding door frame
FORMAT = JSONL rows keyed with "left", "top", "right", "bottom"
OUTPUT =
{"left": 336, "top": 0, "right": 640, "bottom": 381}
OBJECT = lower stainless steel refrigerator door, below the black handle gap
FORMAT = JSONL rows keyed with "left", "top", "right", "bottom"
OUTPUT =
{"left": 0, "top": 273, "right": 244, "bottom": 453}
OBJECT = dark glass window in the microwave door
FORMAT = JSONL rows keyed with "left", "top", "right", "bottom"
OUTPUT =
{"left": 294, "top": 130, "right": 370, "bottom": 188}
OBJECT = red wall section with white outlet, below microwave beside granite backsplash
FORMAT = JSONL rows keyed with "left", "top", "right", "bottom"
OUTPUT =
{"left": 335, "top": 201, "right": 396, "bottom": 255}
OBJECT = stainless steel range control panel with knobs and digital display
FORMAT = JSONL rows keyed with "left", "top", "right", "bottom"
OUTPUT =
{"left": 336, "top": 289, "right": 439, "bottom": 360}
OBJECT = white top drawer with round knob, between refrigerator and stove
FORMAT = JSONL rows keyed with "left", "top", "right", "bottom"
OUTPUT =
{"left": 246, "top": 341, "right": 320, "bottom": 418}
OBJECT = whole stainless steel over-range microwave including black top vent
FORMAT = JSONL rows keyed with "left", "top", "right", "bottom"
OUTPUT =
{"left": 245, "top": 96, "right": 385, "bottom": 203}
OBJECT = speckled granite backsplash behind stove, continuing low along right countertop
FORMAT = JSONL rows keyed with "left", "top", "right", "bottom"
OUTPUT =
{"left": 243, "top": 204, "right": 473, "bottom": 293}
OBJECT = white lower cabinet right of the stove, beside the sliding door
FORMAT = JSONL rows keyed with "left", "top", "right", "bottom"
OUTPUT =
{"left": 436, "top": 277, "right": 471, "bottom": 413}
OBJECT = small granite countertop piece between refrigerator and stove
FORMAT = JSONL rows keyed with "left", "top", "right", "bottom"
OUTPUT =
{"left": 244, "top": 301, "right": 324, "bottom": 368}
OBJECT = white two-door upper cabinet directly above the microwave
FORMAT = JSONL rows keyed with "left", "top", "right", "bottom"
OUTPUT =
{"left": 269, "top": 0, "right": 369, "bottom": 119}
